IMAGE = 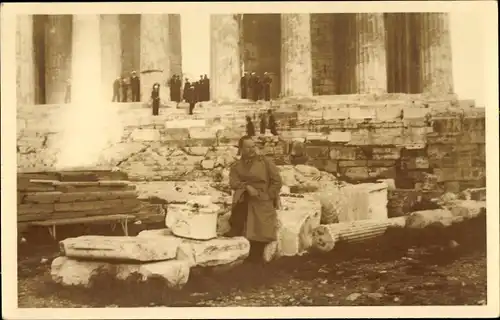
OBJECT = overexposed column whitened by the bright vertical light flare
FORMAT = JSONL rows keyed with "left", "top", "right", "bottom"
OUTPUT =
{"left": 71, "top": 14, "right": 102, "bottom": 104}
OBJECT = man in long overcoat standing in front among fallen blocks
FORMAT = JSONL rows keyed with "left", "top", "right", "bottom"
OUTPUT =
{"left": 229, "top": 136, "right": 282, "bottom": 262}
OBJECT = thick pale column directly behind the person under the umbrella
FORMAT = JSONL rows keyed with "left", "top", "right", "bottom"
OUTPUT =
{"left": 137, "top": 14, "right": 171, "bottom": 102}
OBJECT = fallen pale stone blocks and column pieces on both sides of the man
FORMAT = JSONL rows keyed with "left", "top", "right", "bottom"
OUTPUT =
{"left": 51, "top": 165, "right": 486, "bottom": 288}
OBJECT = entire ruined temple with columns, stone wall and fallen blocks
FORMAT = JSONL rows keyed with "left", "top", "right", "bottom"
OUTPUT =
{"left": 17, "top": 13, "right": 486, "bottom": 287}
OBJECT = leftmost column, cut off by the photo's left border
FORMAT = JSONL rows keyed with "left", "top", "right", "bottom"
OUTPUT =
{"left": 16, "top": 14, "right": 35, "bottom": 105}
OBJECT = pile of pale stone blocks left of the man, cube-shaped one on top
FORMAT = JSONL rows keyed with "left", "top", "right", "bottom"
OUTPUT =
{"left": 51, "top": 197, "right": 250, "bottom": 288}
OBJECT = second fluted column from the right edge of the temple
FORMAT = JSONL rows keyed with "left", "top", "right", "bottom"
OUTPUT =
{"left": 353, "top": 13, "right": 387, "bottom": 94}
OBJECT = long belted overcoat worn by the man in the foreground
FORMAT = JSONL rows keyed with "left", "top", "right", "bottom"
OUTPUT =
{"left": 229, "top": 155, "right": 282, "bottom": 242}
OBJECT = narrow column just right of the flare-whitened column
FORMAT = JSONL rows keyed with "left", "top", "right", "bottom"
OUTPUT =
{"left": 100, "top": 14, "right": 122, "bottom": 101}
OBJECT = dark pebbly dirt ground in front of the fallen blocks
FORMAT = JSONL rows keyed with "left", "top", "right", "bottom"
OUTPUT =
{"left": 18, "top": 218, "right": 486, "bottom": 308}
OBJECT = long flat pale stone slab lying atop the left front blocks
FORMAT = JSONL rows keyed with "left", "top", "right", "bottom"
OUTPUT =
{"left": 59, "top": 236, "right": 180, "bottom": 261}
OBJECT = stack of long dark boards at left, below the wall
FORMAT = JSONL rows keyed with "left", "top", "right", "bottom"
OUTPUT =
{"left": 17, "top": 169, "right": 141, "bottom": 226}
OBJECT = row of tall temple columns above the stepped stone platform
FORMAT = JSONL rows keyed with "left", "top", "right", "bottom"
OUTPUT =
{"left": 17, "top": 13, "right": 453, "bottom": 105}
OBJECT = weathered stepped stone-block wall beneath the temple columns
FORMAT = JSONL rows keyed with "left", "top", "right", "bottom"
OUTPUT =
{"left": 17, "top": 96, "right": 486, "bottom": 191}
